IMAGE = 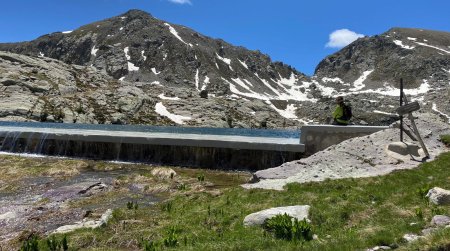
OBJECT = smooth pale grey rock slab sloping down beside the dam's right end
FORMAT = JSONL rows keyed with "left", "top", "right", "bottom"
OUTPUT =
{"left": 243, "top": 113, "right": 450, "bottom": 190}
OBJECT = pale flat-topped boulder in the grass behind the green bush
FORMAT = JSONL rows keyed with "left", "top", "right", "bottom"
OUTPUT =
{"left": 244, "top": 205, "right": 310, "bottom": 226}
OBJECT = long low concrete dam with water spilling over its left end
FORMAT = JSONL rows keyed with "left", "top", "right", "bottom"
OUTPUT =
{"left": 0, "top": 122, "right": 305, "bottom": 170}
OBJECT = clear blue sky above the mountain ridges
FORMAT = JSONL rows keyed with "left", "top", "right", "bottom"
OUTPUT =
{"left": 0, "top": 0, "right": 450, "bottom": 75}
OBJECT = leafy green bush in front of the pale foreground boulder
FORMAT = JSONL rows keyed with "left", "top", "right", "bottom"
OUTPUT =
{"left": 264, "top": 214, "right": 313, "bottom": 241}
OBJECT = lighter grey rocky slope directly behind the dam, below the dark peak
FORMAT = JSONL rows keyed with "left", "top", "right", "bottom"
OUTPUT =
{"left": 0, "top": 52, "right": 294, "bottom": 127}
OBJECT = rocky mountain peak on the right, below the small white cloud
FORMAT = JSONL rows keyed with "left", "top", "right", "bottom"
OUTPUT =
{"left": 315, "top": 28, "right": 450, "bottom": 88}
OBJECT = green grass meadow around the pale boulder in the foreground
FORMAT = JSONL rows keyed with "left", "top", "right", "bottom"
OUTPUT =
{"left": 49, "top": 153, "right": 450, "bottom": 250}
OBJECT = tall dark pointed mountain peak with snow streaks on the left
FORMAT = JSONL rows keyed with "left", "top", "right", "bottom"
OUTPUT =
{"left": 0, "top": 10, "right": 307, "bottom": 100}
